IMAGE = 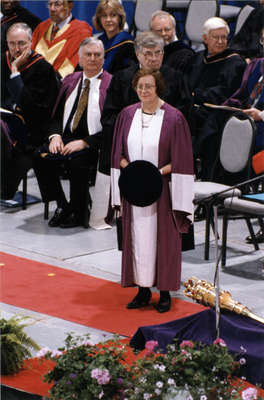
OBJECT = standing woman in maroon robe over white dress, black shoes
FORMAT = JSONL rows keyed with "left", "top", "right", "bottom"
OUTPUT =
{"left": 111, "top": 69, "right": 194, "bottom": 312}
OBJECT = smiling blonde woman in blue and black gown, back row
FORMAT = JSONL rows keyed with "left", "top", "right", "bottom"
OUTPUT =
{"left": 93, "top": 0, "right": 135, "bottom": 74}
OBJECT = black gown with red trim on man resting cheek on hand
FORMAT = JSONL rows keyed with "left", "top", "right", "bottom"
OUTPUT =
{"left": 1, "top": 52, "right": 58, "bottom": 146}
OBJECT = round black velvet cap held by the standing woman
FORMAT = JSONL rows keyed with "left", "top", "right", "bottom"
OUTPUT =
{"left": 118, "top": 160, "right": 162, "bottom": 207}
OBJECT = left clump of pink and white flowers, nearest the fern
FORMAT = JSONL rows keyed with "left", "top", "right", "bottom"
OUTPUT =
{"left": 38, "top": 334, "right": 130, "bottom": 400}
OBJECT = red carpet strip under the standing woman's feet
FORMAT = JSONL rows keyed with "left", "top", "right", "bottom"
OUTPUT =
{"left": 0, "top": 252, "right": 204, "bottom": 336}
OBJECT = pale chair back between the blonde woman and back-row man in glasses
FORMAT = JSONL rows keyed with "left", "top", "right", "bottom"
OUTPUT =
{"left": 132, "top": 0, "right": 164, "bottom": 36}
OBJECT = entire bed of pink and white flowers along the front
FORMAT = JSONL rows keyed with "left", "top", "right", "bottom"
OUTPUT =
{"left": 39, "top": 335, "right": 261, "bottom": 400}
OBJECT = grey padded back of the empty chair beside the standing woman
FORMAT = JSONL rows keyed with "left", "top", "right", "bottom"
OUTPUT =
{"left": 219, "top": 113, "right": 256, "bottom": 176}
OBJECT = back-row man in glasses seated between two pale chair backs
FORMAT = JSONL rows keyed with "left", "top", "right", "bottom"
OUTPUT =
{"left": 149, "top": 10, "right": 194, "bottom": 71}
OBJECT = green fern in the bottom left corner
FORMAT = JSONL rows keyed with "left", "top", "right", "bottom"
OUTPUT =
{"left": 0, "top": 316, "right": 39, "bottom": 375}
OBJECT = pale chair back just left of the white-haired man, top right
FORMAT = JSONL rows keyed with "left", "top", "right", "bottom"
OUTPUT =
{"left": 185, "top": 0, "right": 219, "bottom": 49}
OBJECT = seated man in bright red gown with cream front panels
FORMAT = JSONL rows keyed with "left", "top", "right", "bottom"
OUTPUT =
{"left": 32, "top": 0, "right": 92, "bottom": 78}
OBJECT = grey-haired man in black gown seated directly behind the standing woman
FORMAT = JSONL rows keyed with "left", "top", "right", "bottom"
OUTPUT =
{"left": 99, "top": 32, "right": 188, "bottom": 175}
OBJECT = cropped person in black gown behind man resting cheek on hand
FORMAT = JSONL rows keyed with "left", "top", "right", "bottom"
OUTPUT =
{"left": 0, "top": 0, "right": 41, "bottom": 53}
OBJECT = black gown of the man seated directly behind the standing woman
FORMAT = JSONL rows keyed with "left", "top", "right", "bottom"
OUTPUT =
{"left": 99, "top": 63, "right": 189, "bottom": 175}
